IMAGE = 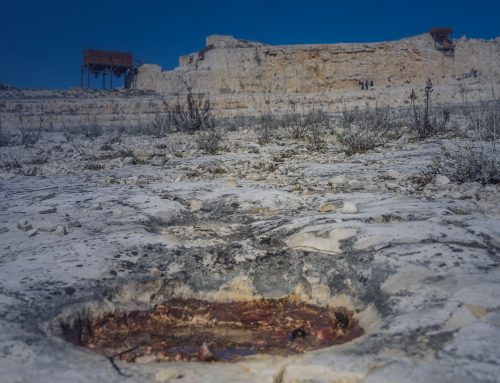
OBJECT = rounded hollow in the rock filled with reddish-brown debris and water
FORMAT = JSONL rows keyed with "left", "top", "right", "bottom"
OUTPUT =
{"left": 63, "top": 298, "right": 363, "bottom": 362}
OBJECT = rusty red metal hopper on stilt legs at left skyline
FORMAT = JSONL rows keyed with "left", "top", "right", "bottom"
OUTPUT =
{"left": 80, "top": 49, "right": 136, "bottom": 89}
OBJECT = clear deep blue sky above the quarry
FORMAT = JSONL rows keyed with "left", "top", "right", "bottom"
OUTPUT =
{"left": 0, "top": 0, "right": 500, "bottom": 88}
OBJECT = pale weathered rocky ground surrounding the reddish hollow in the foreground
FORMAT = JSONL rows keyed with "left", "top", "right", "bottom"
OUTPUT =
{"left": 0, "top": 131, "right": 500, "bottom": 383}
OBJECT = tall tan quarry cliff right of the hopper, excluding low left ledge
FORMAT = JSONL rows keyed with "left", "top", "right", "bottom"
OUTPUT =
{"left": 137, "top": 34, "right": 500, "bottom": 115}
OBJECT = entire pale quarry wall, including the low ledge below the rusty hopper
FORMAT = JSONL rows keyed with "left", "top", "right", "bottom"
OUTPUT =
{"left": 0, "top": 34, "right": 500, "bottom": 130}
